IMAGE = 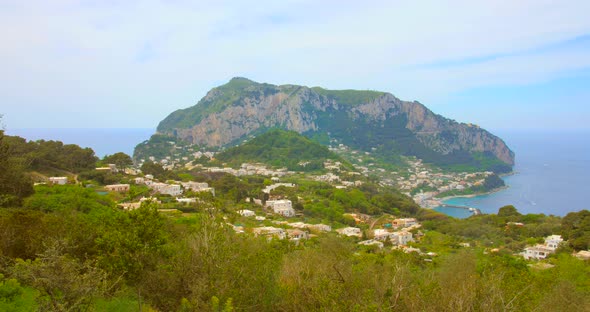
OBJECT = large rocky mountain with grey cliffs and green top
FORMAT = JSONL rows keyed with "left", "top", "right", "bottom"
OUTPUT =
{"left": 157, "top": 77, "right": 514, "bottom": 172}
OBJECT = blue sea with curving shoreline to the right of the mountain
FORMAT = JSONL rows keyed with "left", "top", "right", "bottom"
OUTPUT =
{"left": 435, "top": 131, "right": 590, "bottom": 218}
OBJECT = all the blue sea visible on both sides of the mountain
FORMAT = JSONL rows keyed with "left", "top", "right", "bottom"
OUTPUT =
{"left": 6, "top": 128, "right": 590, "bottom": 218}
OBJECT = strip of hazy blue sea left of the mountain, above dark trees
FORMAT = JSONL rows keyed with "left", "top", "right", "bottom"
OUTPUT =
{"left": 6, "top": 128, "right": 156, "bottom": 158}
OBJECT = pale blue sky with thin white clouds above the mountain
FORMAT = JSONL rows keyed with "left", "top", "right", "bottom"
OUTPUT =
{"left": 0, "top": 0, "right": 590, "bottom": 130}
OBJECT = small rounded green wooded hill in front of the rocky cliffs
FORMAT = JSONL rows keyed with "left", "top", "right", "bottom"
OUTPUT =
{"left": 215, "top": 129, "right": 344, "bottom": 171}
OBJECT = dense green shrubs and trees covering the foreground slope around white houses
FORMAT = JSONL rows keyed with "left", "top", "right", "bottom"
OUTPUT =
{"left": 0, "top": 131, "right": 590, "bottom": 311}
